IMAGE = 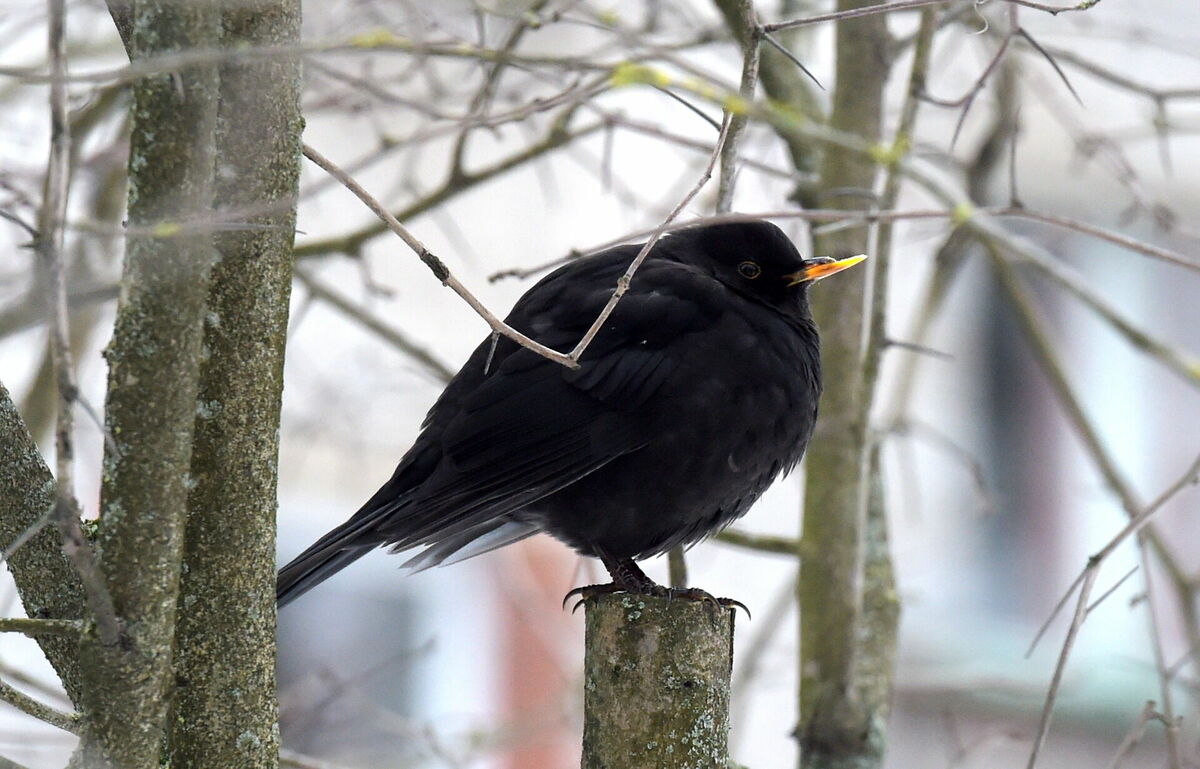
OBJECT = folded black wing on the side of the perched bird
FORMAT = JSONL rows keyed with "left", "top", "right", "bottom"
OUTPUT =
{"left": 378, "top": 261, "right": 715, "bottom": 549}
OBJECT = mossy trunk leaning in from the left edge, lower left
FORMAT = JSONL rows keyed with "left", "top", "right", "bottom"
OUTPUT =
{"left": 0, "top": 384, "right": 84, "bottom": 702}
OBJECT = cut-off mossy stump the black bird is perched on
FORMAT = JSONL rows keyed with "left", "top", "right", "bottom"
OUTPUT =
{"left": 582, "top": 593, "right": 733, "bottom": 769}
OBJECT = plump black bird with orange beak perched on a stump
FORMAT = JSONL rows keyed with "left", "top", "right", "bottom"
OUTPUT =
{"left": 276, "top": 221, "right": 865, "bottom": 605}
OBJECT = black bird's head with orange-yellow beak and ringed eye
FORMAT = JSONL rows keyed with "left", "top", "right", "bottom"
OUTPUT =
{"left": 671, "top": 221, "right": 866, "bottom": 314}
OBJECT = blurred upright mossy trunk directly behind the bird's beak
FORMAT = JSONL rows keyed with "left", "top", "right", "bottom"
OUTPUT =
{"left": 797, "top": 0, "right": 894, "bottom": 768}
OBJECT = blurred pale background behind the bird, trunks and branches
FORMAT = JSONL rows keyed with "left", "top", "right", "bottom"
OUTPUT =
{"left": 0, "top": 0, "right": 1200, "bottom": 769}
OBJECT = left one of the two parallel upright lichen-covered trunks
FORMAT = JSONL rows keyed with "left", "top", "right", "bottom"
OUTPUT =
{"left": 72, "top": 1, "right": 220, "bottom": 769}
